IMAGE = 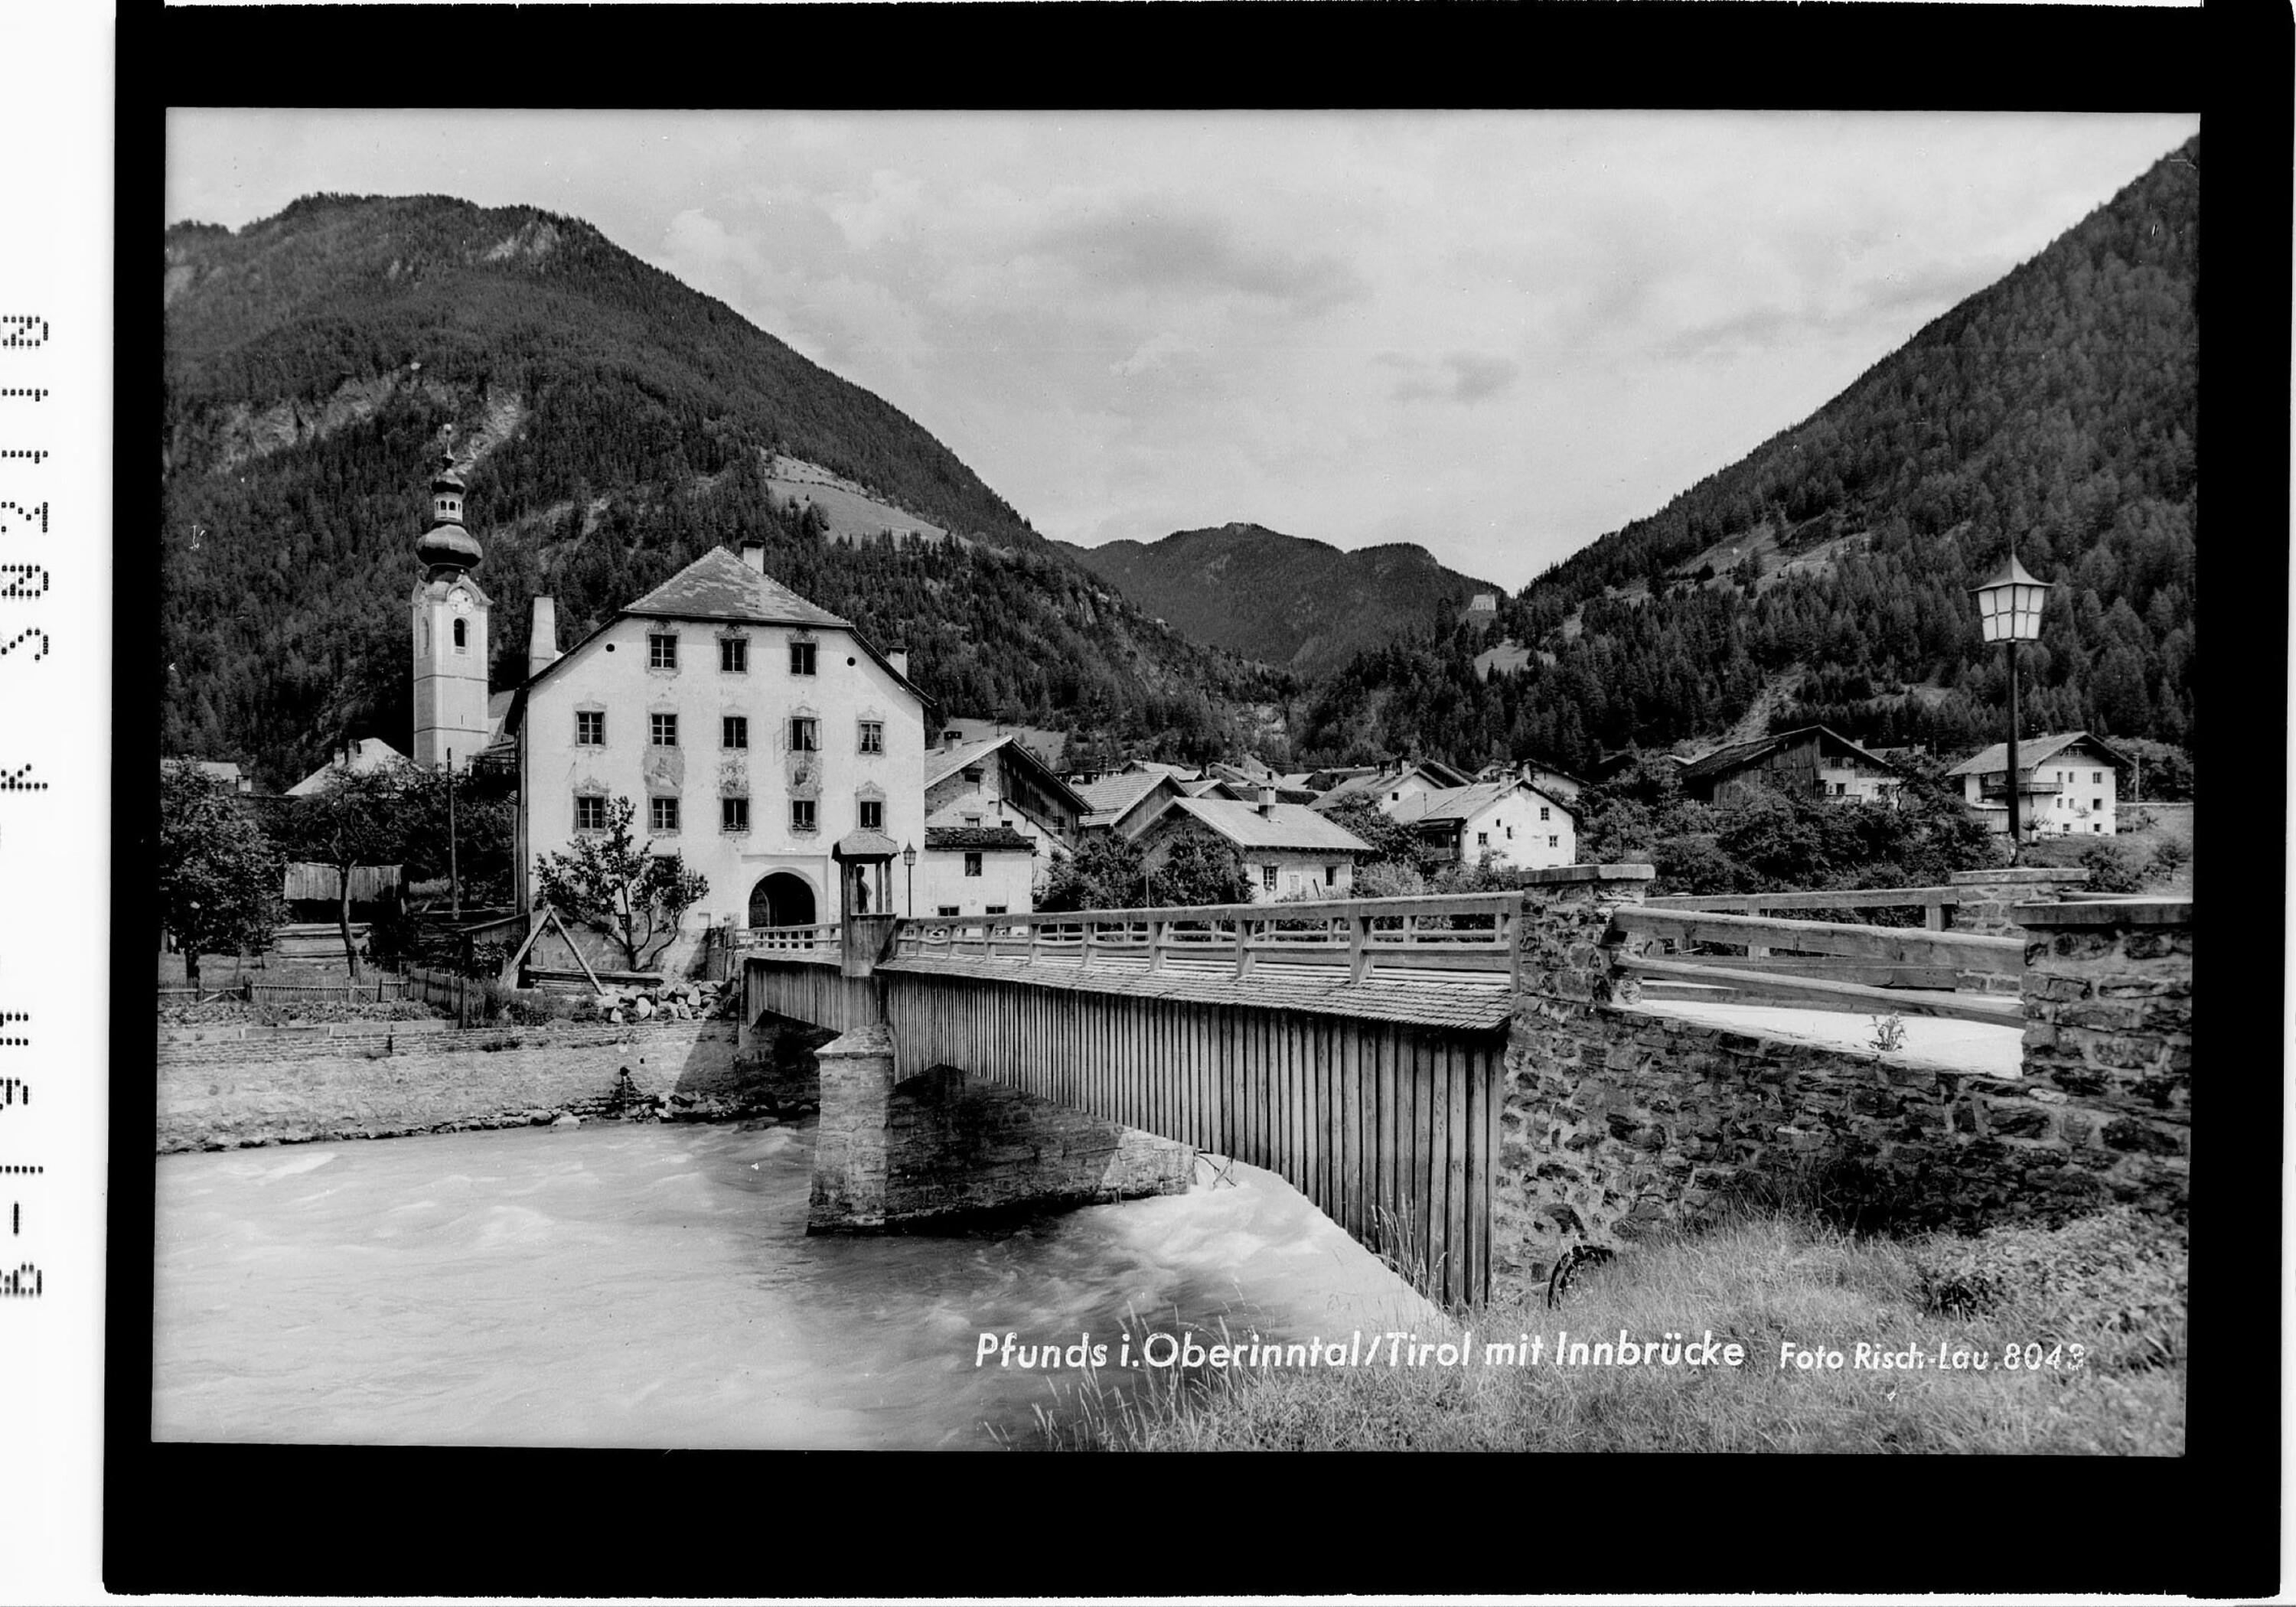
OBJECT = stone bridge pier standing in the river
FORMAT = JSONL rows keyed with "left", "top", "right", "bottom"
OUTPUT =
{"left": 808, "top": 1026, "right": 1196, "bottom": 1233}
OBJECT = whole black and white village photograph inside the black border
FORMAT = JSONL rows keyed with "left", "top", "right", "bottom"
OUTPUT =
{"left": 80, "top": 6, "right": 2287, "bottom": 1593}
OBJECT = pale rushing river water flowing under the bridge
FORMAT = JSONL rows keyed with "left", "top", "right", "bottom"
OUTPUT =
{"left": 152, "top": 1123, "right": 1437, "bottom": 1449}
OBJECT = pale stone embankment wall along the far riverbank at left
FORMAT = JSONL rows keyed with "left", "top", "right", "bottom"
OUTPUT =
{"left": 158, "top": 1022, "right": 792, "bottom": 1152}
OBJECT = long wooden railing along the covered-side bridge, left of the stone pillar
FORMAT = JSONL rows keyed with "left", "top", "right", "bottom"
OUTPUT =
{"left": 893, "top": 893, "right": 1522, "bottom": 983}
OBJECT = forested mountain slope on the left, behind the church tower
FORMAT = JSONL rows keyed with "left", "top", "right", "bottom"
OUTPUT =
{"left": 156, "top": 195, "right": 1277, "bottom": 785}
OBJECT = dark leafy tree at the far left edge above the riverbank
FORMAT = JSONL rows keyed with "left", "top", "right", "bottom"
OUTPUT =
{"left": 154, "top": 764, "right": 287, "bottom": 987}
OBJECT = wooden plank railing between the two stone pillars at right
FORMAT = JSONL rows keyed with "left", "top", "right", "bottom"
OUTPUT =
{"left": 1612, "top": 909, "right": 2025, "bottom": 1024}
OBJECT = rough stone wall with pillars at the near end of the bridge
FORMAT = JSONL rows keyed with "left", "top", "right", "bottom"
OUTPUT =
{"left": 1492, "top": 865, "right": 2190, "bottom": 1288}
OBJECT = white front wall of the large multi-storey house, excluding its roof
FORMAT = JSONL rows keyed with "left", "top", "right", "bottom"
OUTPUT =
{"left": 519, "top": 618, "right": 925, "bottom": 964}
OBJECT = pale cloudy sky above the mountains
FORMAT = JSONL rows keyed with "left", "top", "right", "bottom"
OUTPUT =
{"left": 165, "top": 110, "right": 2200, "bottom": 590}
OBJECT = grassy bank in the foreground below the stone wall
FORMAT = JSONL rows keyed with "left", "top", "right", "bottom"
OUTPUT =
{"left": 1035, "top": 1210, "right": 2186, "bottom": 1455}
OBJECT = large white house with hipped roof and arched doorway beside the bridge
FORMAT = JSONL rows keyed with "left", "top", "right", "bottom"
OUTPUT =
{"left": 505, "top": 528, "right": 932, "bottom": 966}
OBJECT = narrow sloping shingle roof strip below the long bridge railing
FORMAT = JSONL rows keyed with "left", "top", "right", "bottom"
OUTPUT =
{"left": 877, "top": 955, "right": 1515, "bottom": 1031}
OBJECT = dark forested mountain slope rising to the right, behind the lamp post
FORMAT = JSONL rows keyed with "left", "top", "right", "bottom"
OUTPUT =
{"left": 1297, "top": 138, "right": 2200, "bottom": 764}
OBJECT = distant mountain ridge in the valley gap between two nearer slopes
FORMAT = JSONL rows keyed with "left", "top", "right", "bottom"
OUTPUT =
{"left": 1056, "top": 523, "right": 1504, "bottom": 677}
